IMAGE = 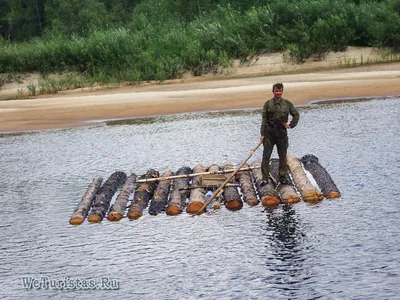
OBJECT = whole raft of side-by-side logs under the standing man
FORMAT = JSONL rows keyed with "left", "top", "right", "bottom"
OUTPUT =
{"left": 70, "top": 155, "right": 340, "bottom": 225}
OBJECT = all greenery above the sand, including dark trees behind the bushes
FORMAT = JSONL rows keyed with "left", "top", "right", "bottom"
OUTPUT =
{"left": 0, "top": 0, "right": 400, "bottom": 95}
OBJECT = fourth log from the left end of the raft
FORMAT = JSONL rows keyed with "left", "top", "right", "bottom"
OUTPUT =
{"left": 127, "top": 169, "right": 160, "bottom": 220}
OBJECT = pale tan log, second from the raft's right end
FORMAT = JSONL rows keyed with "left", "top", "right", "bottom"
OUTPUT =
{"left": 287, "top": 154, "right": 324, "bottom": 201}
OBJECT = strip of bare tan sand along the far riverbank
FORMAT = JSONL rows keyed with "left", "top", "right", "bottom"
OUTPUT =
{"left": 0, "top": 46, "right": 400, "bottom": 132}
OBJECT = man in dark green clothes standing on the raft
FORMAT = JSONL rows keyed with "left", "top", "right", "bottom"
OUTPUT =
{"left": 261, "top": 83, "right": 299, "bottom": 185}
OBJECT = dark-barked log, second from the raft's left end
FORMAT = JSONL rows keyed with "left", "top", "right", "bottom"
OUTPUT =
{"left": 88, "top": 171, "right": 126, "bottom": 223}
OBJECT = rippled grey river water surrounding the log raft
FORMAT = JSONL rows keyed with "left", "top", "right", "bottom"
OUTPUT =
{"left": 0, "top": 97, "right": 400, "bottom": 299}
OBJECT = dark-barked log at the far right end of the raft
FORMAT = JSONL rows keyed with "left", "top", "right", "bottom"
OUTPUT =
{"left": 301, "top": 154, "right": 340, "bottom": 199}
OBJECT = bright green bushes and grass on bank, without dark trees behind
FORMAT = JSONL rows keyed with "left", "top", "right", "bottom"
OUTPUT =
{"left": 0, "top": 0, "right": 400, "bottom": 95}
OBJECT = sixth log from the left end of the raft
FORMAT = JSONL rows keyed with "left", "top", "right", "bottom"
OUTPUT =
{"left": 166, "top": 167, "right": 192, "bottom": 216}
